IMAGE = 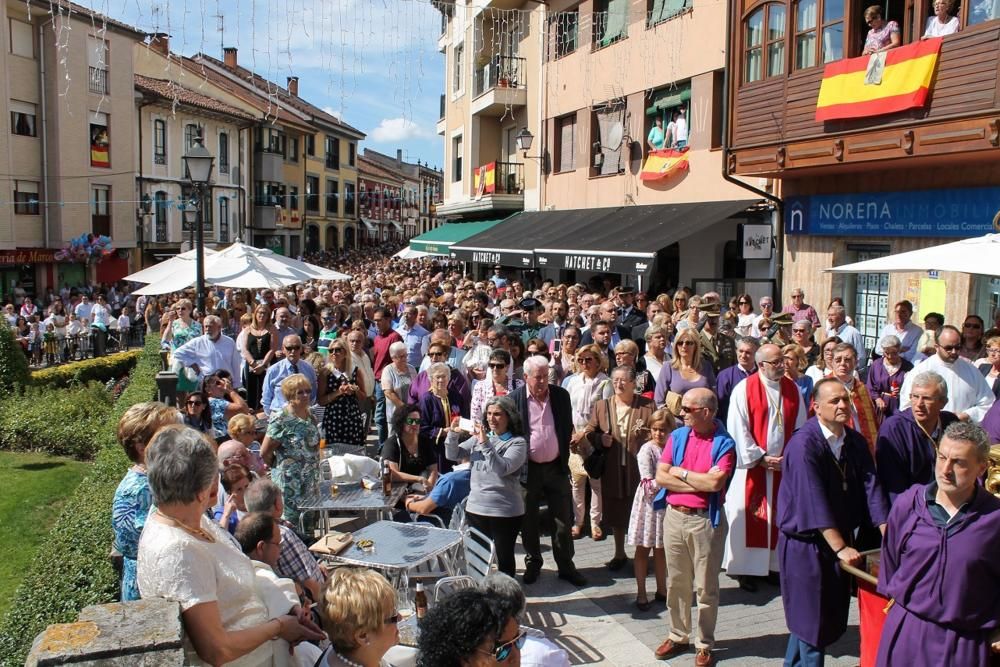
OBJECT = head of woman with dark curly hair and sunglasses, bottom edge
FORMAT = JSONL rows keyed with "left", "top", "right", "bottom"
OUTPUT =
{"left": 417, "top": 588, "right": 526, "bottom": 667}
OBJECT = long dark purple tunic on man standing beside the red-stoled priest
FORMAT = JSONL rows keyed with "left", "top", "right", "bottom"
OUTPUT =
{"left": 778, "top": 417, "right": 889, "bottom": 649}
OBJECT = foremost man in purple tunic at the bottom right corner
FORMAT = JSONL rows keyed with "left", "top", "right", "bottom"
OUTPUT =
{"left": 876, "top": 422, "right": 1000, "bottom": 667}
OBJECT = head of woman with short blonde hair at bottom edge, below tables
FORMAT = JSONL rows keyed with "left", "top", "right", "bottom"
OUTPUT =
{"left": 316, "top": 567, "right": 399, "bottom": 667}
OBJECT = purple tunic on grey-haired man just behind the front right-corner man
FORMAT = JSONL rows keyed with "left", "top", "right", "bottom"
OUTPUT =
{"left": 875, "top": 408, "right": 958, "bottom": 504}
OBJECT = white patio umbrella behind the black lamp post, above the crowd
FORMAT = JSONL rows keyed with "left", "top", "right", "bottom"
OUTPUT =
{"left": 136, "top": 241, "right": 350, "bottom": 294}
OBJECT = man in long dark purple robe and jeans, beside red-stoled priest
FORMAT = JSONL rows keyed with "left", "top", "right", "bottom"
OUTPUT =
{"left": 778, "top": 378, "right": 889, "bottom": 667}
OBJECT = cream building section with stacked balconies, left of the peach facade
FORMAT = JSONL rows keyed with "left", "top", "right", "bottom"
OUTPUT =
{"left": 436, "top": 0, "right": 545, "bottom": 221}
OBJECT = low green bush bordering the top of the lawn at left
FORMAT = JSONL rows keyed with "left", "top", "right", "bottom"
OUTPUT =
{"left": 0, "top": 383, "right": 114, "bottom": 459}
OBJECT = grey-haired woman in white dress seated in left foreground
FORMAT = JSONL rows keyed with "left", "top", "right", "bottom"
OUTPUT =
{"left": 137, "top": 425, "right": 324, "bottom": 667}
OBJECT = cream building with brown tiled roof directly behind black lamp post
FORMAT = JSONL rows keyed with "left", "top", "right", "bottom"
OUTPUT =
{"left": 134, "top": 34, "right": 258, "bottom": 264}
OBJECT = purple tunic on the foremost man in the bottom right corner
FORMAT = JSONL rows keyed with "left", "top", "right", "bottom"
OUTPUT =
{"left": 876, "top": 486, "right": 1000, "bottom": 667}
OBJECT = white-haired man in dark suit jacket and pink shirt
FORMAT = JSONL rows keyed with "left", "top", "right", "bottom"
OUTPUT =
{"left": 511, "top": 356, "right": 587, "bottom": 586}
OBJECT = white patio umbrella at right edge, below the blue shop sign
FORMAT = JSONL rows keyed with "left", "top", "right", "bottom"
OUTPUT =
{"left": 826, "top": 234, "right": 1000, "bottom": 276}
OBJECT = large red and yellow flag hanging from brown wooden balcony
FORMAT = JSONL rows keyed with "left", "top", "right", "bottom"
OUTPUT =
{"left": 816, "top": 37, "right": 941, "bottom": 121}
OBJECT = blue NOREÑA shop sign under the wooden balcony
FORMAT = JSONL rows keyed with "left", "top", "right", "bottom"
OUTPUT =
{"left": 785, "top": 187, "right": 1000, "bottom": 238}
